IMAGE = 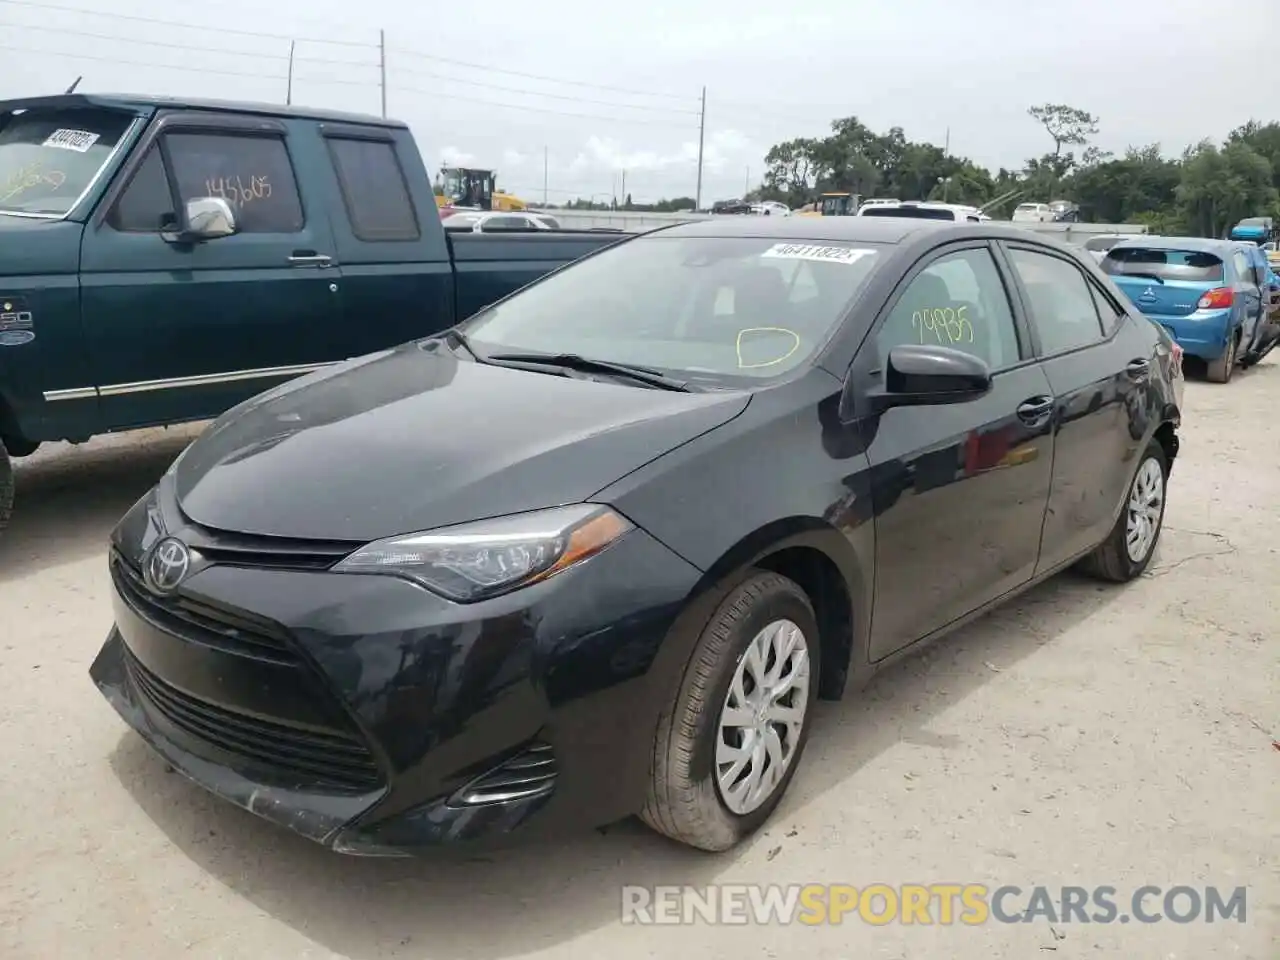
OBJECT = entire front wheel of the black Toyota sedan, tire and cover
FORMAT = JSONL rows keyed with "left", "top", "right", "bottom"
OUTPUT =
{"left": 640, "top": 572, "right": 819, "bottom": 852}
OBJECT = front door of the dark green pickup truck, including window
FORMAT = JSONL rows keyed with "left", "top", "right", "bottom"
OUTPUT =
{"left": 81, "top": 113, "right": 344, "bottom": 429}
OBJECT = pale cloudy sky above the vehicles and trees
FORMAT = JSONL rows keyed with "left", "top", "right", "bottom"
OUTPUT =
{"left": 0, "top": 0, "right": 1280, "bottom": 204}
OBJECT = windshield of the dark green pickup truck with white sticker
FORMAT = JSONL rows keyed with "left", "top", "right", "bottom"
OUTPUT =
{"left": 0, "top": 109, "right": 133, "bottom": 216}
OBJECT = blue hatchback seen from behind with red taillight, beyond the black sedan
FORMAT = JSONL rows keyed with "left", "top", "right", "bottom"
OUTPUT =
{"left": 1100, "top": 237, "right": 1275, "bottom": 383}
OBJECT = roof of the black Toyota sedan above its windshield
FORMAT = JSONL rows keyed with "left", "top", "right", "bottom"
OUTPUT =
{"left": 645, "top": 216, "right": 1060, "bottom": 246}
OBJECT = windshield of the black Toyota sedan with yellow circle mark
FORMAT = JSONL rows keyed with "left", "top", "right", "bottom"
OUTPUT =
{"left": 461, "top": 237, "right": 879, "bottom": 387}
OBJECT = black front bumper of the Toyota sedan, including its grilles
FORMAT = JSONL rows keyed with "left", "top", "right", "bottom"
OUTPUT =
{"left": 90, "top": 504, "right": 700, "bottom": 856}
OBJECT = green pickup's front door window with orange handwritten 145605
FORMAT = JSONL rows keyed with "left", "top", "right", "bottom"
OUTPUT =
{"left": 165, "top": 133, "right": 305, "bottom": 233}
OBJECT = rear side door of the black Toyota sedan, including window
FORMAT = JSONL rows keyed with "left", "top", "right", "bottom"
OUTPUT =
{"left": 1002, "top": 242, "right": 1141, "bottom": 576}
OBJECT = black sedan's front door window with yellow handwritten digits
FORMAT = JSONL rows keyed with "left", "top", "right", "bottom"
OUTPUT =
{"left": 876, "top": 248, "right": 1019, "bottom": 370}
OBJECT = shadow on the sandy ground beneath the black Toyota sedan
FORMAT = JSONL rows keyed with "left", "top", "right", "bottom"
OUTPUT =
{"left": 110, "top": 575, "right": 1120, "bottom": 960}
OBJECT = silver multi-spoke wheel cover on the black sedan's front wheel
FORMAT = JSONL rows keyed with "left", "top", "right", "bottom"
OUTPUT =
{"left": 716, "top": 620, "right": 810, "bottom": 817}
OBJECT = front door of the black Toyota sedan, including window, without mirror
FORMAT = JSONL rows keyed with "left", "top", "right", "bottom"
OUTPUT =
{"left": 854, "top": 243, "right": 1053, "bottom": 659}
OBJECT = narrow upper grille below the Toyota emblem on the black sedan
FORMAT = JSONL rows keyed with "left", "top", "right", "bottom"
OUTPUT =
{"left": 111, "top": 552, "right": 300, "bottom": 664}
